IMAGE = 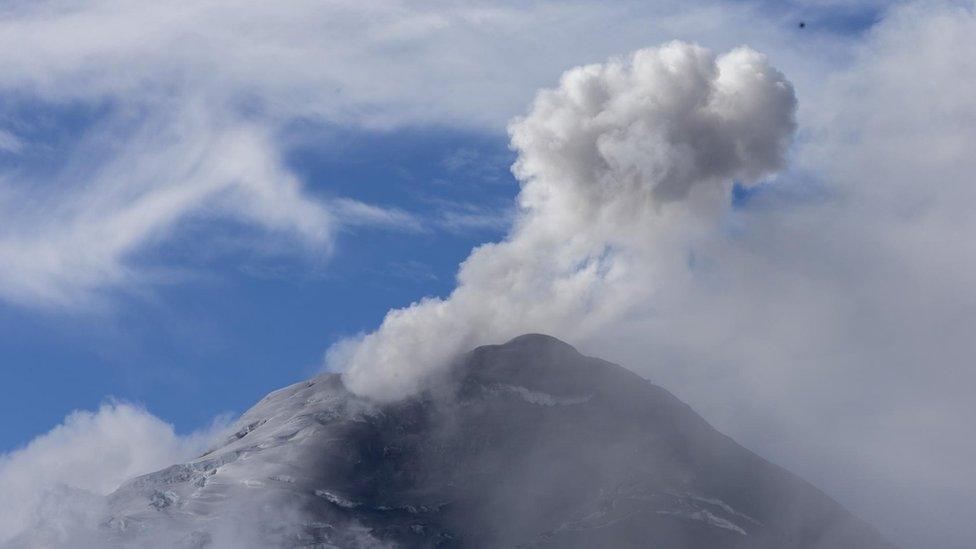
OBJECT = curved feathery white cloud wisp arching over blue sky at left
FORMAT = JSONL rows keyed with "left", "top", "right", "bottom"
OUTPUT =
{"left": 0, "top": 108, "right": 336, "bottom": 306}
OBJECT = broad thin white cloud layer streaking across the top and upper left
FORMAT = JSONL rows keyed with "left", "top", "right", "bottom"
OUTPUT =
{"left": 0, "top": 0, "right": 848, "bottom": 307}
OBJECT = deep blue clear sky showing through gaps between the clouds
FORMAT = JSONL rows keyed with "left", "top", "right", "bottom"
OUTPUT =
{"left": 0, "top": 2, "right": 879, "bottom": 450}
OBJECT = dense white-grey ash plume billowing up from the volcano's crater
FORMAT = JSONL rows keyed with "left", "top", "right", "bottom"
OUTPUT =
{"left": 327, "top": 42, "right": 796, "bottom": 400}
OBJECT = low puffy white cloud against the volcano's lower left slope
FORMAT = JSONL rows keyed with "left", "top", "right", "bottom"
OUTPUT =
{"left": 0, "top": 403, "right": 225, "bottom": 547}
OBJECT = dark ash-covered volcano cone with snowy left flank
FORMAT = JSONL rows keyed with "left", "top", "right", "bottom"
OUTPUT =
{"left": 61, "top": 335, "right": 891, "bottom": 549}
